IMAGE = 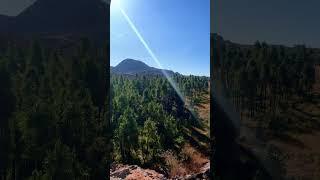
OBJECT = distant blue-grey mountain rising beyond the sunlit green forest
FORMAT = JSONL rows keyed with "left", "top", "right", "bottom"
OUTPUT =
{"left": 110, "top": 59, "right": 174, "bottom": 75}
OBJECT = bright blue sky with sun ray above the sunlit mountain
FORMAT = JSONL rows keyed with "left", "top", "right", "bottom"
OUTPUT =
{"left": 110, "top": 0, "right": 210, "bottom": 76}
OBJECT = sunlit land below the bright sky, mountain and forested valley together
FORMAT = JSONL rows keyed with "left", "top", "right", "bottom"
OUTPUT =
{"left": 110, "top": 59, "right": 210, "bottom": 178}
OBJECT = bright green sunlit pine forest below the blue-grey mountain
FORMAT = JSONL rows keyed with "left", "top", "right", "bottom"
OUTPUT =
{"left": 111, "top": 73, "right": 209, "bottom": 176}
